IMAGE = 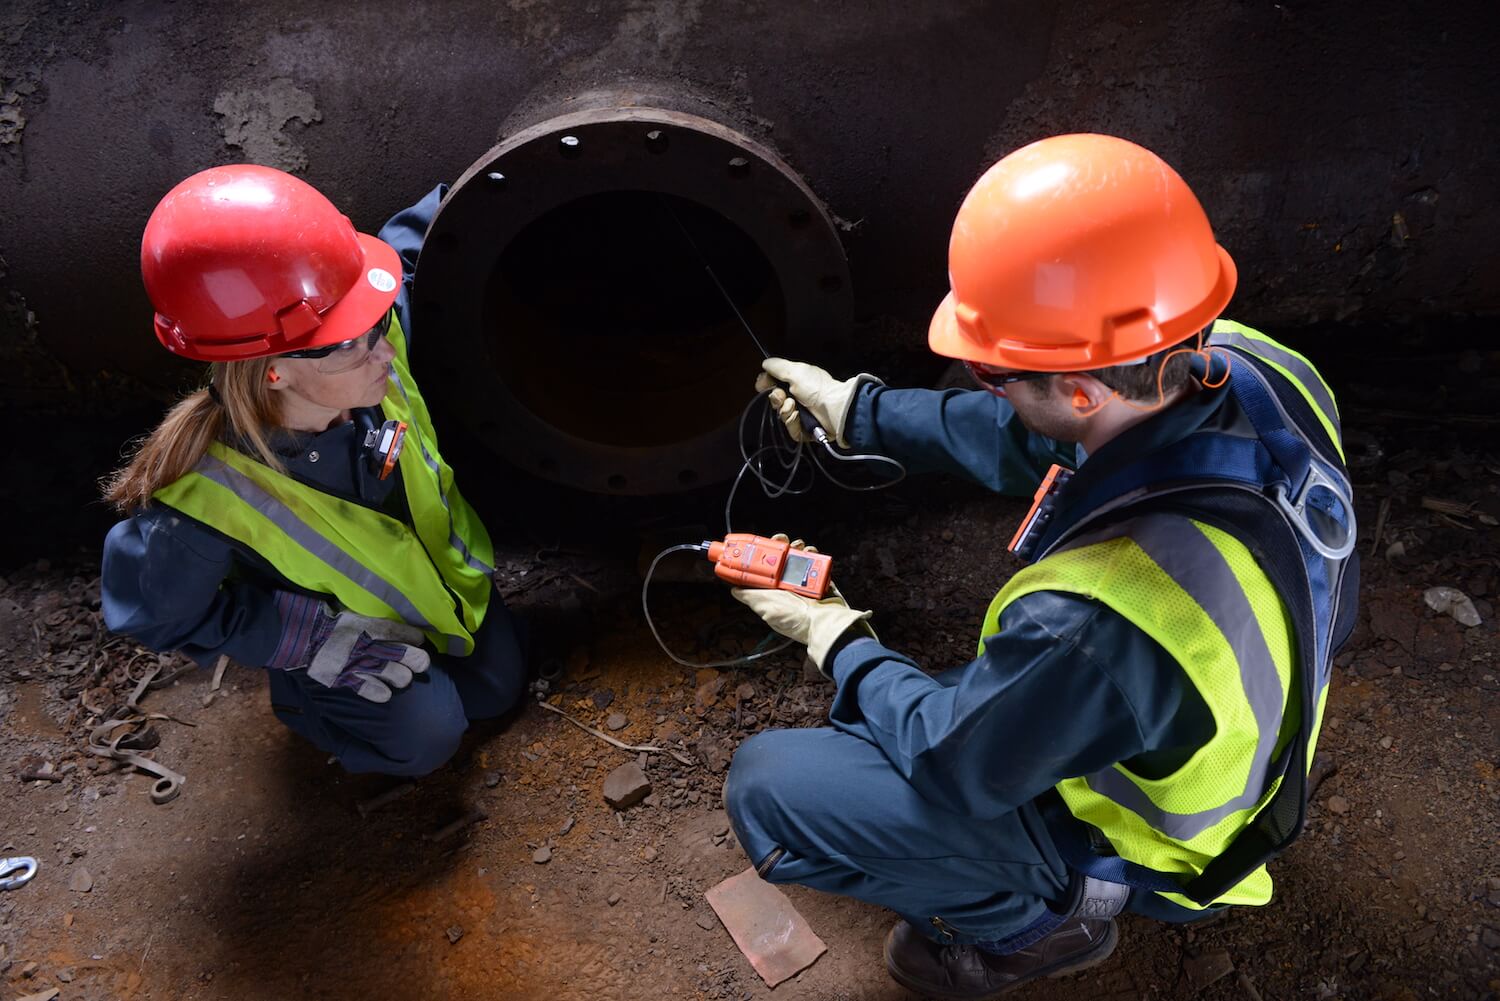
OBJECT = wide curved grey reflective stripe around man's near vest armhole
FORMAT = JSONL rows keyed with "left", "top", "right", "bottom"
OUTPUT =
{"left": 1068, "top": 515, "right": 1284, "bottom": 840}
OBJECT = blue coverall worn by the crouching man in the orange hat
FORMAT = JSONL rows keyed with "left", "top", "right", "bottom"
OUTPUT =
{"left": 725, "top": 379, "right": 1232, "bottom": 951}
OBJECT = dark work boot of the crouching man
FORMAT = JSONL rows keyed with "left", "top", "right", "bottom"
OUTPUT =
{"left": 885, "top": 917, "right": 1119, "bottom": 998}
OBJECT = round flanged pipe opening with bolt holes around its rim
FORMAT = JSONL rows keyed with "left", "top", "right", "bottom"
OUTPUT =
{"left": 414, "top": 107, "right": 851, "bottom": 495}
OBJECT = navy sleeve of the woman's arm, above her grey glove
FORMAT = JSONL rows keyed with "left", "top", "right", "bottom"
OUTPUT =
{"left": 99, "top": 509, "right": 281, "bottom": 666}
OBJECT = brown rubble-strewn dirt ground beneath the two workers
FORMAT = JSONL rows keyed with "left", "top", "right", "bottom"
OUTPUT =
{"left": 0, "top": 333, "right": 1500, "bottom": 1001}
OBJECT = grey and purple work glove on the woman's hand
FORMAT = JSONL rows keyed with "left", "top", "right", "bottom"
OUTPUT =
{"left": 266, "top": 591, "right": 432, "bottom": 702}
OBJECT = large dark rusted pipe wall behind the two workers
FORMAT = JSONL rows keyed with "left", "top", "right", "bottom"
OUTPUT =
{"left": 0, "top": 0, "right": 1500, "bottom": 405}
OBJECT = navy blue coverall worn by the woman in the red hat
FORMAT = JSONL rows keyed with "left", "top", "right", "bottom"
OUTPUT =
{"left": 101, "top": 186, "right": 527, "bottom": 776}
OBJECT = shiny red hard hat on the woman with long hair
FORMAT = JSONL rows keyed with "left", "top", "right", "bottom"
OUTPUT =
{"left": 141, "top": 164, "right": 401, "bottom": 362}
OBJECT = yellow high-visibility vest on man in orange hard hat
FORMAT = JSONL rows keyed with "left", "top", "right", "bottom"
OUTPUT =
{"left": 980, "top": 320, "right": 1343, "bottom": 908}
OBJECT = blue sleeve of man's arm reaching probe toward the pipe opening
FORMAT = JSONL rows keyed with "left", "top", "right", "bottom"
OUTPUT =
{"left": 845, "top": 384, "right": 1079, "bottom": 495}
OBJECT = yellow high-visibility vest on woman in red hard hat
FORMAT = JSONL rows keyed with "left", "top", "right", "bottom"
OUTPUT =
{"left": 155, "top": 321, "right": 495, "bottom": 656}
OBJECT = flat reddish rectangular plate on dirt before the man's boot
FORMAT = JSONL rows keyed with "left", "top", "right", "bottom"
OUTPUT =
{"left": 704, "top": 867, "right": 828, "bottom": 987}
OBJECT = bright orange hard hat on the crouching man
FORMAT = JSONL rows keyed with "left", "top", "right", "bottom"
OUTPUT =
{"left": 927, "top": 134, "right": 1236, "bottom": 372}
